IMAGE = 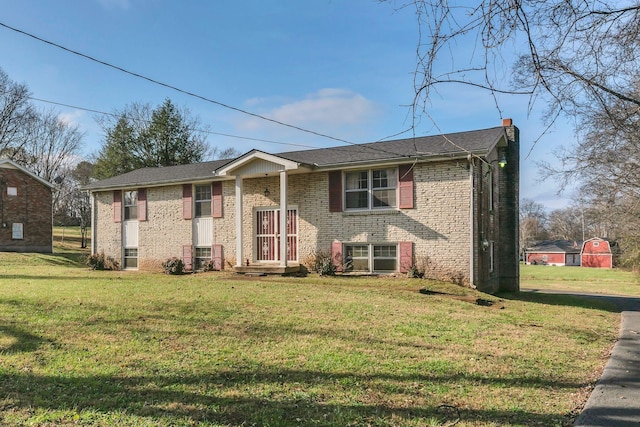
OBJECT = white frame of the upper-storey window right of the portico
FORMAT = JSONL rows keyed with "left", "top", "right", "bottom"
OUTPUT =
{"left": 342, "top": 167, "right": 399, "bottom": 211}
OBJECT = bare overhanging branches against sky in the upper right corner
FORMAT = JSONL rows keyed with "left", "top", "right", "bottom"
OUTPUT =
{"left": 405, "top": 0, "right": 640, "bottom": 132}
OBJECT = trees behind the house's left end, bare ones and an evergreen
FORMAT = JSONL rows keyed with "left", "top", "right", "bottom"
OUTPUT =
{"left": 0, "top": 69, "right": 237, "bottom": 247}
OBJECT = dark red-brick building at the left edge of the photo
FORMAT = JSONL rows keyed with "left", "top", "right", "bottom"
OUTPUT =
{"left": 0, "top": 159, "right": 53, "bottom": 253}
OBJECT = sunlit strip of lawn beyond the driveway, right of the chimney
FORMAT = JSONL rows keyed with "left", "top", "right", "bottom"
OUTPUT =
{"left": 520, "top": 264, "right": 640, "bottom": 296}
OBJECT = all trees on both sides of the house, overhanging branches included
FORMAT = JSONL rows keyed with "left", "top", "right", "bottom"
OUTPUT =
{"left": 0, "top": 0, "right": 640, "bottom": 268}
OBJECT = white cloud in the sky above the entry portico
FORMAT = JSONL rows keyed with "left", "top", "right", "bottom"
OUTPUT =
{"left": 239, "top": 88, "right": 378, "bottom": 131}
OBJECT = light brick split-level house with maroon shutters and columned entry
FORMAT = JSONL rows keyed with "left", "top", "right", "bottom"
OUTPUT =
{"left": 85, "top": 119, "right": 519, "bottom": 292}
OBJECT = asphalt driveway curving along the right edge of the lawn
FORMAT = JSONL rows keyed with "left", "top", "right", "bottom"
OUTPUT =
{"left": 522, "top": 289, "right": 640, "bottom": 427}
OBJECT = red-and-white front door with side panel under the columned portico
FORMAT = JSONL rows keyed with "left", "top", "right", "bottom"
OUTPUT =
{"left": 255, "top": 208, "right": 298, "bottom": 262}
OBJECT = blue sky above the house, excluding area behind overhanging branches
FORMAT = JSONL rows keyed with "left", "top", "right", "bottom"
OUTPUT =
{"left": 0, "top": 0, "right": 573, "bottom": 209}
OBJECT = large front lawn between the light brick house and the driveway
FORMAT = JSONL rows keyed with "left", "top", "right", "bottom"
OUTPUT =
{"left": 0, "top": 253, "right": 619, "bottom": 426}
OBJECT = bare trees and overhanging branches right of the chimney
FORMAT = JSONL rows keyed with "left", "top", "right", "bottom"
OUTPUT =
{"left": 402, "top": 0, "right": 640, "bottom": 268}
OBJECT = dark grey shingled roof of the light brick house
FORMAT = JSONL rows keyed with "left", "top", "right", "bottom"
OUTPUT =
{"left": 83, "top": 126, "right": 506, "bottom": 190}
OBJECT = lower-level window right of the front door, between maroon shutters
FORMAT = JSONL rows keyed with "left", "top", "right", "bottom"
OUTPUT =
{"left": 344, "top": 244, "right": 398, "bottom": 272}
